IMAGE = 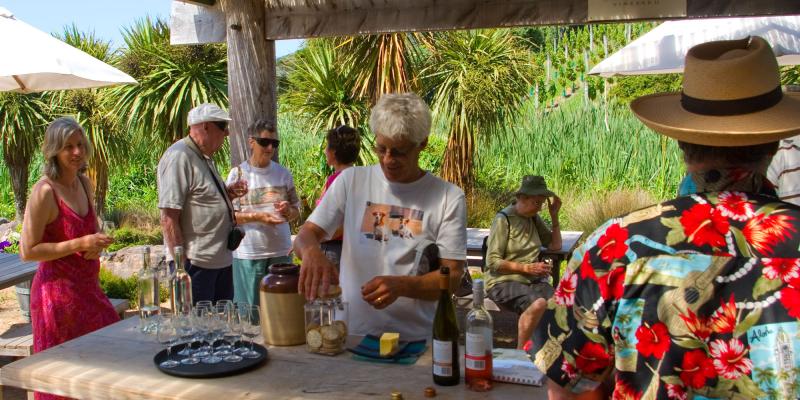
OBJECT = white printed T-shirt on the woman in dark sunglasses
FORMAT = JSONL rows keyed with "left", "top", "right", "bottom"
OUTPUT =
{"left": 227, "top": 161, "right": 300, "bottom": 260}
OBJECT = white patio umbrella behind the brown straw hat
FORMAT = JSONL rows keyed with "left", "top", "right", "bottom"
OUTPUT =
{"left": 589, "top": 16, "right": 800, "bottom": 77}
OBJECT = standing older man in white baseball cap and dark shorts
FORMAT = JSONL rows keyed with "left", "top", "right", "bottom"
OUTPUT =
{"left": 158, "top": 103, "right": 247, "bottom": 302}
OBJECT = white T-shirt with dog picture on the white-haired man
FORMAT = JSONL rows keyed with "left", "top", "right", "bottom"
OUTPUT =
{"left": 308, "top": 165, "right": 467, "bottom": 340}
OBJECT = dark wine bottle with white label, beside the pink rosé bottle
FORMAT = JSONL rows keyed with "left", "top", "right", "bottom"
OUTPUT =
{"left": 433, "top": 267, "right": 461, "bottom": 386}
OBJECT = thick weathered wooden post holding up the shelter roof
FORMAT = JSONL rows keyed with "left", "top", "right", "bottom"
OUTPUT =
{"left": 220, "top": 0, "right": 278, "bottom": 165}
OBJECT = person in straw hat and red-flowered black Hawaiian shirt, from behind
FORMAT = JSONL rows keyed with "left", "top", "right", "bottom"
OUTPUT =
{"left": 532, "top": 37, "right": 800, "bottom": 399}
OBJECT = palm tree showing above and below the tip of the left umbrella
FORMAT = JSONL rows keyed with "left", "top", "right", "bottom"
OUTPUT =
{"left": 48, "top": 24, "right": 128, "bottom": 216}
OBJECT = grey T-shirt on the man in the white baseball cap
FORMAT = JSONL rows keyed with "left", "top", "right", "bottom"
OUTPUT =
{"left": 158, "top": 138, "right": 233, "bottom": 269}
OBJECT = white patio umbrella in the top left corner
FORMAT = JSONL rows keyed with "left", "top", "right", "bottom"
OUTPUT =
{"left": 0, "top": 7, "right": 136, "bottom": 93}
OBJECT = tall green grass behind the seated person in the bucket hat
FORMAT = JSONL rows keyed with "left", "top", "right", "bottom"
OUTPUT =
{"left": 477, "top": 96, "right": 684, "bottom": 203}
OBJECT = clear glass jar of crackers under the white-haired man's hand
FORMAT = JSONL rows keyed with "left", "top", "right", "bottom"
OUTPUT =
{"left": 304, "top": 285, "right": 348, "bottom": 356}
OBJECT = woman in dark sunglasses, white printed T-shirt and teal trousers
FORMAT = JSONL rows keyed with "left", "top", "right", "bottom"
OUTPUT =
{"left": 228, "top": 120, "right": 300, "bottom": 304}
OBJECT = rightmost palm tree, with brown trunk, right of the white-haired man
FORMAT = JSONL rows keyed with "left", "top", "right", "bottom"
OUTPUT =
{"left": 421, "top": 29, "right": 534, "bottom": 191}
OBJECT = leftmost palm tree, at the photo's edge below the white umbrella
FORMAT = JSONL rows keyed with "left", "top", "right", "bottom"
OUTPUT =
{"left": 0, "top": 92, "right": 50, "bottom": 221}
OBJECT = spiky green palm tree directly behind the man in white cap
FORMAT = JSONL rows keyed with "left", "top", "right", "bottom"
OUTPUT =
{"left": 114, "top": 18, "right": 228, "bottom": 157}
